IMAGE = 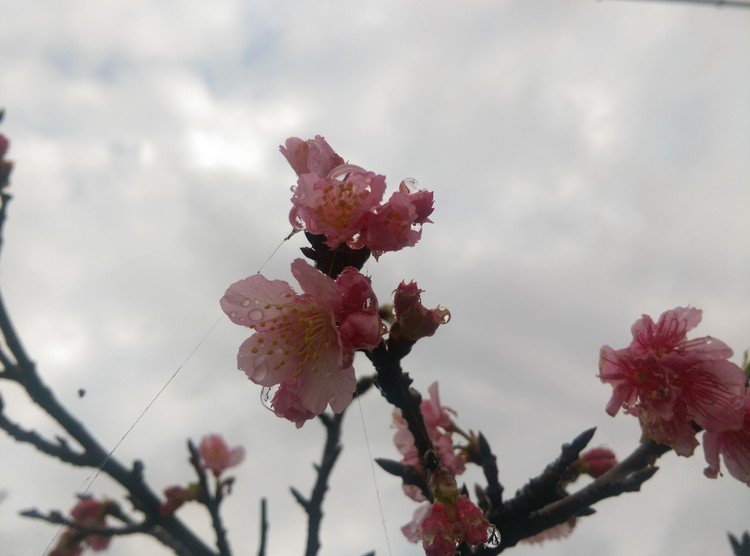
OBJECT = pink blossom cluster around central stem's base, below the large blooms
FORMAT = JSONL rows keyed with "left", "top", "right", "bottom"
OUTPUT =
{"left": 393, "top": 382, "right": 489, "bottom": 556}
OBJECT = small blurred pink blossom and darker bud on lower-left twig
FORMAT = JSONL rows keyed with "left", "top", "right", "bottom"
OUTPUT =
{"left": 159, "top": 434, "right": 245, "bottom": 517}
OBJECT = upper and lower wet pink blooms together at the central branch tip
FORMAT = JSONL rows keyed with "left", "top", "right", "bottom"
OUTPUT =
{"left": 220, "top": 136, "right": 438, "bottom": 428}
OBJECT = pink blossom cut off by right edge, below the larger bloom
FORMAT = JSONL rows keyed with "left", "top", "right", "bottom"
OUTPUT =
{"left": 703, "top": 392, "right": 750, "bottom": 486}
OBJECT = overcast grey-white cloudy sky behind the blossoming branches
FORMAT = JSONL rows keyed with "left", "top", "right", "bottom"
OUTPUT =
{"left": 0, "top": 0, "right": 750, "bottom": 556}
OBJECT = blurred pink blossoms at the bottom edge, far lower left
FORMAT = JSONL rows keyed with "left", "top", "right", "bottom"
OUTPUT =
{"left": 49, "top": 498, "right": 113, "bottom": 556}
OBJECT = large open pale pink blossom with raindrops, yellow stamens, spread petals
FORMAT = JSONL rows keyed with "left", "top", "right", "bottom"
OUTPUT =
{"left": 221, "top": 259, "right": 383, "bottom": 416}
